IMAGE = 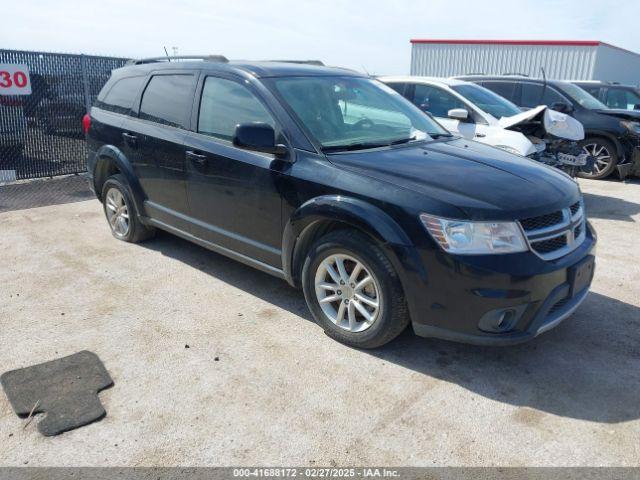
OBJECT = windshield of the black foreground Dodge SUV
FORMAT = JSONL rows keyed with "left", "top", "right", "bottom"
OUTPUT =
{"left": 273, "top": 76, "right": 450, "bottom": 151}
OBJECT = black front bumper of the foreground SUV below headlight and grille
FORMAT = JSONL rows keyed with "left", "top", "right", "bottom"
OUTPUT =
{"left": 407, "top": 224, "right": 596, "bottom": 346}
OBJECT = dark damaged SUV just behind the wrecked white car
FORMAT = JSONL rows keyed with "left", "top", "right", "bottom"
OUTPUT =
{"left": 457, "top": 75, "right": 640, "bottom": 178}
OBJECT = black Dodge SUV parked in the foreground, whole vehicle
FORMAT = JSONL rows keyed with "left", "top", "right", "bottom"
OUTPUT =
{"left": 84, "top": 57, "right": 595, "bottom": 348}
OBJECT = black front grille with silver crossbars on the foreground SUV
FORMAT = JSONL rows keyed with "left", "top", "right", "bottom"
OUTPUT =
{"left": 520, "top": 201, "right": 585, "bottom": 260}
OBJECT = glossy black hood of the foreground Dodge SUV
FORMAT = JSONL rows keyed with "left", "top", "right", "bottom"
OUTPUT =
{"left": 328, "top": 138, "right": 580, "bottom": 220}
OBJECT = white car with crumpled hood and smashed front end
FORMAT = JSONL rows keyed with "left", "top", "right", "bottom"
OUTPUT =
{"left": 378, "top": 76, "right": 589, "bottom": 174}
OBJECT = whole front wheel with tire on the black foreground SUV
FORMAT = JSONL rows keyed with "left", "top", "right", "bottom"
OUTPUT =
{"left": 302, "top": 230, "right": 409, "bottom": 348}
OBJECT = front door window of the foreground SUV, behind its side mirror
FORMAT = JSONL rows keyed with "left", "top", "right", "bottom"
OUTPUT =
{"left": 198, "top": 77, "right": 275, "bottom": 140}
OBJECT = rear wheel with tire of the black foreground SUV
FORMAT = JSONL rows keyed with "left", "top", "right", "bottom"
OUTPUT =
{"left": 102, "top": 173, "right": 156, "bottom": 243}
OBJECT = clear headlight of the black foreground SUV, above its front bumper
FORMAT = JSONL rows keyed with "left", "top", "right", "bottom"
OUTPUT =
{"left": 420, "top": 213, "right": 529, "bottom": 255}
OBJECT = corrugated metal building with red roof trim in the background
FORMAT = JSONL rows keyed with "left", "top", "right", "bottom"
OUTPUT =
{"left": 411, "top": 39, "right": 640, "bottom": 85}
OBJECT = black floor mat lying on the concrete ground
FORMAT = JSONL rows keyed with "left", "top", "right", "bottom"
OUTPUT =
{"left": 0, "top": 350, "right": 113, "bottom": 436}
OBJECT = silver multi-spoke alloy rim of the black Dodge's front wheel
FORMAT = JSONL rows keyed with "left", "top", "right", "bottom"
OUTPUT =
{"left": 315, "top": 254, "right": 382, "bottom": 332}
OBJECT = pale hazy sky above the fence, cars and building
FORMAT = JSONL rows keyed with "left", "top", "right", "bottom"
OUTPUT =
{"left": 0, "top": 0, "right": 640, "bottom": 74}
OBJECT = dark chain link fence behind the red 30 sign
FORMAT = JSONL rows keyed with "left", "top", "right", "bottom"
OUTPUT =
{"left": 0, "top": 49, "right": 127, "bottom": 182}
